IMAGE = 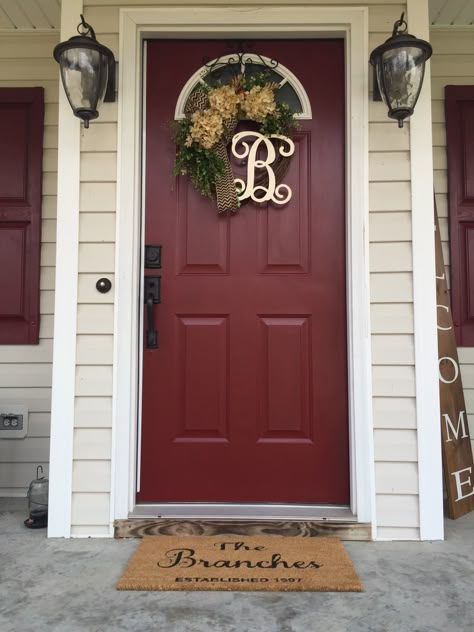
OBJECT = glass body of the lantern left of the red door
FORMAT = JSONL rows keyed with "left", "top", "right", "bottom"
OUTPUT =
{"left": 61, "top": 48, "right": 108, "bottom": 115}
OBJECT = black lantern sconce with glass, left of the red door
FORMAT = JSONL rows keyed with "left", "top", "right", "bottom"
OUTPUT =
{"left": 53, "top": 15, "right": 115, "bottom": 128}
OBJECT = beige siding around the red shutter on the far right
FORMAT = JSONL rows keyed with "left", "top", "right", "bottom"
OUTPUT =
{"left": 430, "top": 27, "right": 474, "bottom": 448}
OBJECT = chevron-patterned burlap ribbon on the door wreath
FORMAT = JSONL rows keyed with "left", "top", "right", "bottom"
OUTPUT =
{"left": 184, "top": 88, "right": 239, "bottom": 213}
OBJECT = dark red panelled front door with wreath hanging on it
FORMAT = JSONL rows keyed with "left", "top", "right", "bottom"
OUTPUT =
{"left": 137, "top": 40, "right": 349, "bottom": 504}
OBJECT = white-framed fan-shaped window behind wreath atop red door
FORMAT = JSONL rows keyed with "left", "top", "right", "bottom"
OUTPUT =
{"left": 175, "top": 53, "right": 312, "bottom": 119}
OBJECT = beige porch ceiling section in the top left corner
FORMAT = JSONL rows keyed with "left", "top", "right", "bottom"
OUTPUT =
{"left": 0, "top": 0, "right": 61, "bottom": 31}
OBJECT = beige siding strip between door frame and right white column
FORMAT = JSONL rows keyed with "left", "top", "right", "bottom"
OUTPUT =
{"left": 369, "top": 27, "right": 419, "bottom": 540}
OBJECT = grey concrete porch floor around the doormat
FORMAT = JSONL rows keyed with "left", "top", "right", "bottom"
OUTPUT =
{"left": 0, "top": 499, "right": 474, "bottom": 632}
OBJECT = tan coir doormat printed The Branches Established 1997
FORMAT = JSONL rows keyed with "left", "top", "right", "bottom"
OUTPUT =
{"left": 117, "top": 536, "right": 364, "bottom": 592}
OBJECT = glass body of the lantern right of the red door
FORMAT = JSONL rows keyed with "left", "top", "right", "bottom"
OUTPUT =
{"left": 377, "top": 47, "right": 424, "bottom": 109}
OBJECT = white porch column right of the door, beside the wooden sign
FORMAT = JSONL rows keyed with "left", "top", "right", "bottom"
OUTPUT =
{"left": 407, "top": 0, "right": 444, "bottom": 540}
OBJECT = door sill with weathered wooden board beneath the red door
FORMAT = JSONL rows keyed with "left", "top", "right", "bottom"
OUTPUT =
{"left": 114, "top": 504, "right": 372, "bottom": 541}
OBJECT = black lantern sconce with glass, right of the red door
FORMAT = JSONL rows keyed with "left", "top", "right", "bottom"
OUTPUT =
{"left": 370, "top": 13, "right": 433, "bottom": 127}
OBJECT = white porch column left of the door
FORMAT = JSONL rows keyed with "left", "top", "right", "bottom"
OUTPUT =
{"left": 48, "top": 0, "right": 83, "bottom": 538}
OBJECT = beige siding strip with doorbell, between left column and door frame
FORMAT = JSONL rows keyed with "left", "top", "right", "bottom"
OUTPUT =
{"left": 71, "top": 56, "right": 118, "bottom": 537}
